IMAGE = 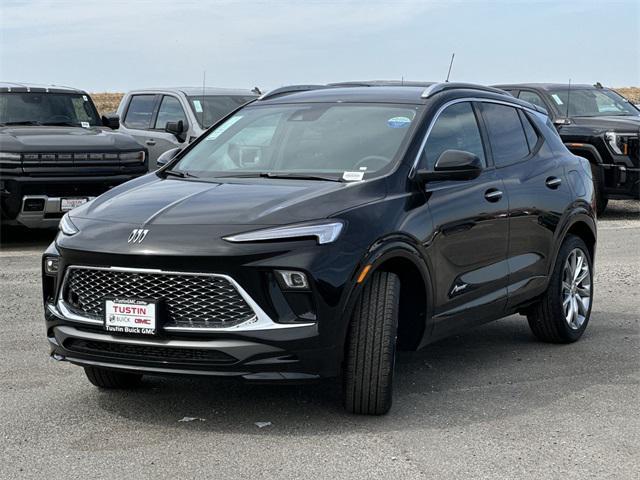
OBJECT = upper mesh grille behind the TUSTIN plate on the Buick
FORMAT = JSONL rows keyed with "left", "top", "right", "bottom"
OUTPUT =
{"left": 62, "top": 267, "right": 255, "bottom": 329}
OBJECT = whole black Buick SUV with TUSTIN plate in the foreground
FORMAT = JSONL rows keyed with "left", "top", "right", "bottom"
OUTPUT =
{"left": 43, "top": 83, "right": 596, "bottom": 414}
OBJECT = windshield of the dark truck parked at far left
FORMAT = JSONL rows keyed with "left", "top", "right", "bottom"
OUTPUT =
{"left": 0, "top": 92, "right": 100, "bottom": 127}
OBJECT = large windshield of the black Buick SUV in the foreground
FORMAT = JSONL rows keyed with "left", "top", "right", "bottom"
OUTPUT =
{"left": 172, "top": 103, "right": 419, "bottom": 180}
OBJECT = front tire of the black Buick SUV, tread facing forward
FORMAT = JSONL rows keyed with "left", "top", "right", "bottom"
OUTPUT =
{"left": 343, "top": 272, "right": 400, "bottom": 415}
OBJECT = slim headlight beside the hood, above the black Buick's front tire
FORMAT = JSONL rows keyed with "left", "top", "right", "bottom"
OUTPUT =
{"left": 224, "top": 220, "right": 344, "bottom": 245}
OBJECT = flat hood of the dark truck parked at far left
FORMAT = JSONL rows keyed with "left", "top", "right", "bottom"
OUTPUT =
{"left": 0, "top": 126, "right": 142, "bottom": 152}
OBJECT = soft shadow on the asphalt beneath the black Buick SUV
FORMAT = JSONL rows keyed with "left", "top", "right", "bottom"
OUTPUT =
{"left": 78, "top": 315, "right": 635, "bottom": 435}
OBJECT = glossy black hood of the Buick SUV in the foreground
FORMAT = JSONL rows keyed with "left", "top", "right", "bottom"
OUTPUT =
{"left": 70, "top": 173, "right": 384, "bottom": 227}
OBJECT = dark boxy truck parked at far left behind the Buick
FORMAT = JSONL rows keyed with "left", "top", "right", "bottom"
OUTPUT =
{"left": 0, "top": 83, "right": 148, "bottom": 228}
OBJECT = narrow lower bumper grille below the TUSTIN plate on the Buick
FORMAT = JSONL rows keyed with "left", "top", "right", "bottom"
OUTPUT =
{"left": 64, "top": 338, "right": 236, "bottom": 364}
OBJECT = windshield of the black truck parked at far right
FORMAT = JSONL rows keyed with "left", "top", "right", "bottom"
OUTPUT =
{"left": 549, "top": 88, "right": 640, "bottom": 117}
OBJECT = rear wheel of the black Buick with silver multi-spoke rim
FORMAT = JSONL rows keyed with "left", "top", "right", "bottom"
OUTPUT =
{"left": 527, "top": 235, "right": 593, "bottom": 343}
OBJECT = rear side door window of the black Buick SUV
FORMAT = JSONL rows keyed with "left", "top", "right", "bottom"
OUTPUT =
{"left": 482, "top": 103, "right": 529, "bottom": 167}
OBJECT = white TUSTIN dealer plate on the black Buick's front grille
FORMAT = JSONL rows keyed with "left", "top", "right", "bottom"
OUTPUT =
{"left": 104, "top": 298, "right": 158, "bottom": 335}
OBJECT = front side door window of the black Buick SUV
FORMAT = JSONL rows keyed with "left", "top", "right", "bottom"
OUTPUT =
{"left": 420, "top": 102, "right": 485, "bottom": 170}
